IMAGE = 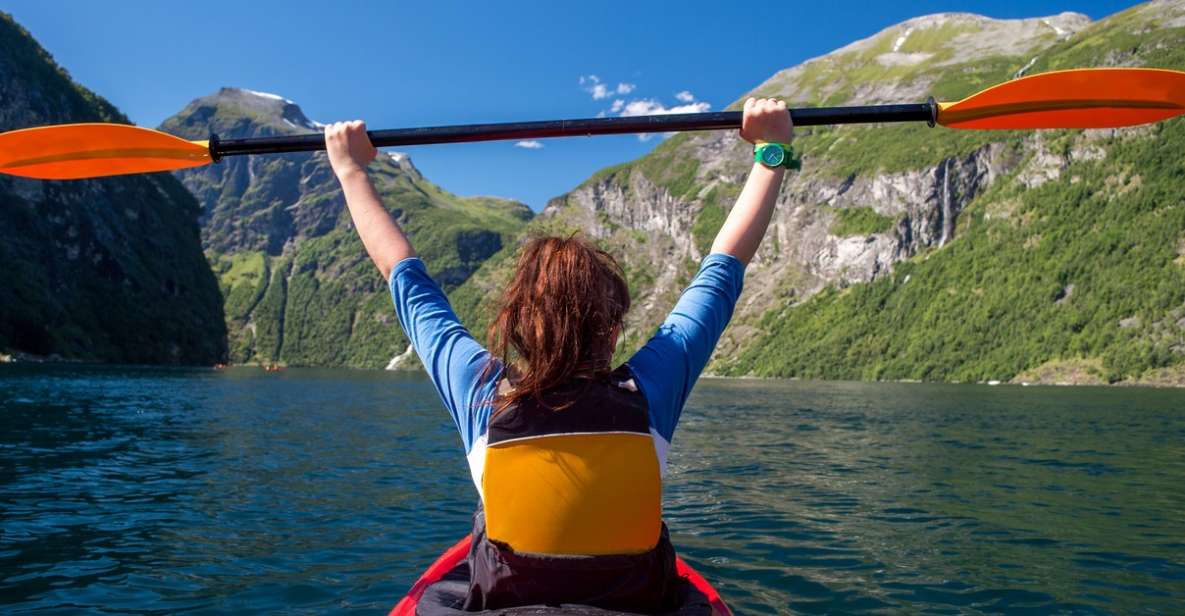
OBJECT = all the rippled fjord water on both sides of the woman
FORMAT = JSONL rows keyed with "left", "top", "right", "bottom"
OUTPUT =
{"left": 0, "top": 366, "right": 1185, "bottom": 614}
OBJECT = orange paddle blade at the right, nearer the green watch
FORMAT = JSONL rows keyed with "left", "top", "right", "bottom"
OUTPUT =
{"left": 939, "top": 69, "right": 1185, "bottom": 129}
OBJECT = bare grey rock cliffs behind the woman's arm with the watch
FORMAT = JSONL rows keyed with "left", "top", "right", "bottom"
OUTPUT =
{"left": 519, "top": 135, "right": 1019, "bottom": 354}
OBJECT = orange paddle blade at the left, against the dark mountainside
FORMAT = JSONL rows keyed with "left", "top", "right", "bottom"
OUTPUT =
{"left": 0, "top": 123, "right": 210, "bottom": 180}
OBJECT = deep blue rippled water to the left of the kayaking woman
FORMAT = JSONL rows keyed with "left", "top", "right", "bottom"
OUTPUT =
{"left": 0, "top": 366, "right": 474, "bottom": 614}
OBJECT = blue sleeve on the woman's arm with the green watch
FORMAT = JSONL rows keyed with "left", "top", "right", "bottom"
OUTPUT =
{"left": 628, "top": 254, "right": 744, "bottom": 443}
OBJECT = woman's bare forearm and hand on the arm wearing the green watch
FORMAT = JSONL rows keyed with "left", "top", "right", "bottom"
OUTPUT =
{"left": 712, "top": 98, "right": 794, "bottom": 264}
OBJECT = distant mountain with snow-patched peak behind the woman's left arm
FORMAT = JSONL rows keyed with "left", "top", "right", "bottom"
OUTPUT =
{"left": 161, "top": 88, "right": 532, "bottom": 367}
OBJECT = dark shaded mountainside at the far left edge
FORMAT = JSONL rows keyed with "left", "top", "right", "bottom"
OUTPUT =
{"left": 0, "top": 13, "right": 226, "bottom": 365}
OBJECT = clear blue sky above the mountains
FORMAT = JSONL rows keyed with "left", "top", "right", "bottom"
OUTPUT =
{"left": 0, "top": 0, "right": 1135, "bottom": 210}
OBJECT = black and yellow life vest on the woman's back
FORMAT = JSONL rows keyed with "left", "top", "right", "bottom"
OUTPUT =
{"left": 481, "top": 368, "right": 662, "bottom": 556}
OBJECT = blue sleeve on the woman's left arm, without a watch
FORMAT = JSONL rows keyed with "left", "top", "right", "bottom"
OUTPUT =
{"left": 390, "top": 257, "right": 501, "bottom": 454}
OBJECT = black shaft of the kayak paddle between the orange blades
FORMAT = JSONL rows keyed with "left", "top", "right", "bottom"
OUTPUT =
{"left": 210, "top": 98, "right": 939, "bottom": 161}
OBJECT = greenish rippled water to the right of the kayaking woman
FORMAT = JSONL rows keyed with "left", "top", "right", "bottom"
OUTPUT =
{"left": 667, "top": 381, "right": 1185, "bottom": 612}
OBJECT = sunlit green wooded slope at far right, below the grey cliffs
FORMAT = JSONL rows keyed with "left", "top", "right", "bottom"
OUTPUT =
{"left": 725, "top": 4, "right": 1185, "bottom": 381}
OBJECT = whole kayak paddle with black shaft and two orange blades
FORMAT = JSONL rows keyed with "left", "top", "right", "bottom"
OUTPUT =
{"left": 0, "top": 69, "right": 1185, "bottom": 180}
